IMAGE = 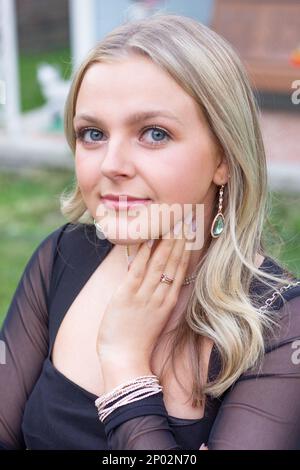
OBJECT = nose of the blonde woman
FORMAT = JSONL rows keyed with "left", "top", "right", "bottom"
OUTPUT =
{"left": 101, "top": 139, "right": 135, "bottom": 179}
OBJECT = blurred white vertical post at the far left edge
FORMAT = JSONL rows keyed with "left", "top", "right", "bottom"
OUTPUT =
{"left": 0, "top": 0, "right": 20, "bottom": 133}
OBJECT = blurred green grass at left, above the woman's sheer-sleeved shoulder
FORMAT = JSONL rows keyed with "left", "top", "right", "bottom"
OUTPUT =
{"left": 0, "top": 170, "right": 73, "bottom": 324}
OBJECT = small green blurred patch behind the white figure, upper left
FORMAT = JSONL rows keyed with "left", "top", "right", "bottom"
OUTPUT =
{"left": 19, "top": 48, "right": 72, "bottom": 112}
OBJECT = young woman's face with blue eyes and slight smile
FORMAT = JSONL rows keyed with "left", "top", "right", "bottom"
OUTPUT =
{"left": 74, "top": 56, "right": 227, "bottom": 244}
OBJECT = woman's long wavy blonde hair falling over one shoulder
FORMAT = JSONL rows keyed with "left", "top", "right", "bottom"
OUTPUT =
{"left": 62, "top": 13, "right": 296, "bottom": 406}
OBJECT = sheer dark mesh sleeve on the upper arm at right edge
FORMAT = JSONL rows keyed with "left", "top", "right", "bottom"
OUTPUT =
{"left": 208, "top": 288, "right": 300, "bottom": 450}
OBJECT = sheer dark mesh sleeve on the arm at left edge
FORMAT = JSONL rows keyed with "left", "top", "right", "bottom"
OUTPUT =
{"left": 0, "top": 224, "right": 67, "bottom": 449}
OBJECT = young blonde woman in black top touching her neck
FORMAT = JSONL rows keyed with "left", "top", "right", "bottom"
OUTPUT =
{"left": 0, "top": 15, "right": 300, "bottom": 450}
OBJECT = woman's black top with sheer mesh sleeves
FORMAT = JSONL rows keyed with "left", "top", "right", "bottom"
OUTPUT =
{"left": 0, "top": 223, "right": 300, "bottom": 450}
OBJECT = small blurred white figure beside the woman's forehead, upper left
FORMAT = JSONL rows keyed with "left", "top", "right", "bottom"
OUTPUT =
{"left": 37, "top": 63, "right": 71, "bottom": 127}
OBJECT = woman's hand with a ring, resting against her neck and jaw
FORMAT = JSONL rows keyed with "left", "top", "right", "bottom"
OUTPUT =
{"left": 97, "top": 215, "right": 191, "bottom": 370}
